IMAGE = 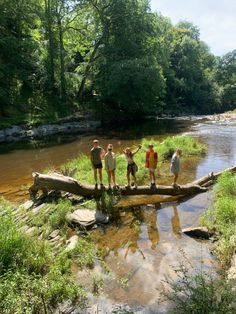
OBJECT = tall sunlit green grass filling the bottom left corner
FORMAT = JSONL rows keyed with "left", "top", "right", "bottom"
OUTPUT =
{"left": 0, "top": 200, "right": 85, "bottom": 314}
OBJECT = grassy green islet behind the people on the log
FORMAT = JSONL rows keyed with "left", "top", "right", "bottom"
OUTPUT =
{"left": 61, "top": 136, "right": 206, "bottom": 185}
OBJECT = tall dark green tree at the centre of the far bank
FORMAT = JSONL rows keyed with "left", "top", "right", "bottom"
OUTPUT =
{"left": 94, "top": 0, "right": 165, "bottom": 117}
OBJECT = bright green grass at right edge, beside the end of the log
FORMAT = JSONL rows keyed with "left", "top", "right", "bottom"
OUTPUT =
{"left": 201, "top": 172, "right": 236, "bottom": 265}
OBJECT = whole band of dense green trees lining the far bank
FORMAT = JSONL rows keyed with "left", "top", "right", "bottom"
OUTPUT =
{"left": 0, "top": 0, "right": 236, "bottom": 123}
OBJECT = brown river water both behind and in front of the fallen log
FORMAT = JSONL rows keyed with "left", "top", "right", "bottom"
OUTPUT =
{"left": 0, "top": 117, "right": 236, "bottom": 314}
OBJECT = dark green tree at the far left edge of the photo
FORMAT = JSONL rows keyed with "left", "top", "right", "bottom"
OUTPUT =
{"left": 0, "top": 0, "right": 38, "bottom": 114}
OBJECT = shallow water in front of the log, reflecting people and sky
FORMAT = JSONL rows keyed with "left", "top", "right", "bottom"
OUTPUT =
{"left": 89, "top": 194, "right": 216, "bottom": 314}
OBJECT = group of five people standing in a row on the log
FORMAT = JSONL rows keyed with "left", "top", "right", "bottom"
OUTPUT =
{"left": 90, "top": 140, "right": 182, "bottom": 189}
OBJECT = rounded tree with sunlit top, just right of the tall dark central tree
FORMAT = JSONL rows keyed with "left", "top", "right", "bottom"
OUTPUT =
{"left": 167, "top": 22, "right": 222, "bottom": 113}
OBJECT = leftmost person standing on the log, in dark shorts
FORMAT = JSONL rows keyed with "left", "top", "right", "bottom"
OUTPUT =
{"left": 90, "top": 140, "right": 105, "bottom": 189}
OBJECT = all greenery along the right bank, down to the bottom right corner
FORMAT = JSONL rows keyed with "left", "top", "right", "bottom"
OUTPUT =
{"left": 165, "top": 172, "right": 236, "bottom": 314}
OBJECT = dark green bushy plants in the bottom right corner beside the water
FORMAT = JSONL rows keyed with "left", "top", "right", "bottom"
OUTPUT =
{"left": 163, "top": 265, "right": 235, "bottom": 314}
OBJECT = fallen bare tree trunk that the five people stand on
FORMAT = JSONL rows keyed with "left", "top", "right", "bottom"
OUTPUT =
{"left": 29, "top": 166, "right": 236, "bottom": 197}
